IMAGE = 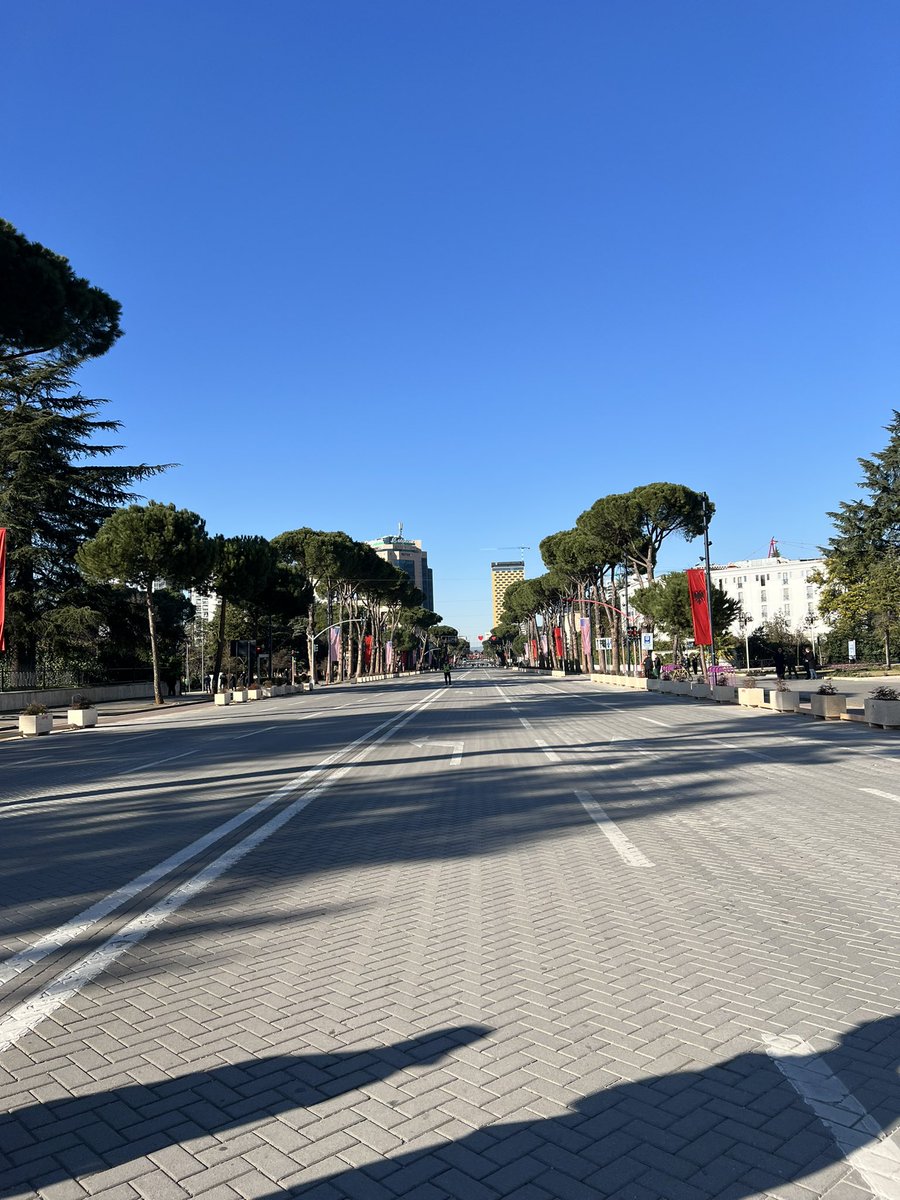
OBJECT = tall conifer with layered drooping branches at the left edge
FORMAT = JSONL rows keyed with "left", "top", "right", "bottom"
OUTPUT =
{"left": 0, "top": 362, "right": 167, "bottom": 673}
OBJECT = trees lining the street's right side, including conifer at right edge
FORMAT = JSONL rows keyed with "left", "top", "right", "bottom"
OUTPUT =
{"left": 494, "top": 410, "right": 900, "bottom": 673}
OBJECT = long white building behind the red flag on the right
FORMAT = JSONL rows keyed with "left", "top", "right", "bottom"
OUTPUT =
{"left": 710, "top": 558, "right": 828, "bottom": 637}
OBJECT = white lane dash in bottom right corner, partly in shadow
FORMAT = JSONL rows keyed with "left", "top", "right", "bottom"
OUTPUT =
{"left": 763, "top": 1034, "right": 900, "bottom": 1200}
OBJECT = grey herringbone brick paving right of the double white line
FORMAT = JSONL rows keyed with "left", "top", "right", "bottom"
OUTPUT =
{"left": 0, "top": 686, "right": 900, "bottom": 1200}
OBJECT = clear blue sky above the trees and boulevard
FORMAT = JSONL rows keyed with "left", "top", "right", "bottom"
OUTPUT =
{"left": 0, "top": 0, "right": 900, "bottom": 640}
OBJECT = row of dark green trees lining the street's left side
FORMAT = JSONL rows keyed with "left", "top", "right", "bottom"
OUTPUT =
{"left": 0, "top": 221, "right": 463, "bottom": 703}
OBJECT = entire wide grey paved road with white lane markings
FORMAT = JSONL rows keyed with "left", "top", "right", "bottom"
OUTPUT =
{"left": 0, "top": 670, "right": 900, "bottom": 1200}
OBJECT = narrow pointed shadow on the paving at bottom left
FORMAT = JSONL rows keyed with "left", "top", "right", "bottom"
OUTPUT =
{"left": 0, "top": 1025, "right": 491, "bottom": 1196}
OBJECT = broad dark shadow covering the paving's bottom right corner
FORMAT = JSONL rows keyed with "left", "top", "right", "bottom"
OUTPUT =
{"left": 248, "top": 1016, "right": 900, "bottom": 1200}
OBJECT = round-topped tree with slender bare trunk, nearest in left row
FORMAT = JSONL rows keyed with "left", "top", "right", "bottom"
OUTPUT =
{"left": 77, "top": 500, "right": 215, "bottom": 704}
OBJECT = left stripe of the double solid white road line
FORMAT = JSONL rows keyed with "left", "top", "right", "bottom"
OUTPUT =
{"left": 0, "top": 691, "right": 443, "bottom": 988}
